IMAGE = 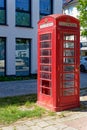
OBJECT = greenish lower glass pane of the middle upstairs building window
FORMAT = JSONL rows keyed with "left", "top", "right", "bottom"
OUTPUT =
{"left": 16, "top": 12, "right": 30, "bottom": 26}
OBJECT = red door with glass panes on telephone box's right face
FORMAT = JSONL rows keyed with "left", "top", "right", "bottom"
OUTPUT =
{"left": 60, "top": 30, "right": 80, "bottom": 106}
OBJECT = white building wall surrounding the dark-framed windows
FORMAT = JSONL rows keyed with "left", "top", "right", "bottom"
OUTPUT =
{"left": 0, "top": 0, "right": 62, "bottom": 75}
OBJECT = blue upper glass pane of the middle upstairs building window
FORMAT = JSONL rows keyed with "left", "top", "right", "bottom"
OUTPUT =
{"left": 16, "top": 0, "right": 30, "bottom": 11}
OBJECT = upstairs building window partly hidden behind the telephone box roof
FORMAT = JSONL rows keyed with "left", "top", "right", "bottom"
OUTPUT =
{"left": 40, "top": 0, "right": 53, "bottom": 18}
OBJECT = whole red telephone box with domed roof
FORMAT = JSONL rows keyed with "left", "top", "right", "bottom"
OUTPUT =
{"left": 37, "top": 14, "right": 80, "bottom": 111}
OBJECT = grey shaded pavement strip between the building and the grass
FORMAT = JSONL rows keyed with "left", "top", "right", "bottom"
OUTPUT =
{"left": 0, "top": 80, "right": 37, "bottom": 97}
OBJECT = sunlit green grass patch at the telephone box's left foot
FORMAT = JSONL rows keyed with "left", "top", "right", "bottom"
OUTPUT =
{"left": 0, "top": 94, "right": 49, "bottom": 124}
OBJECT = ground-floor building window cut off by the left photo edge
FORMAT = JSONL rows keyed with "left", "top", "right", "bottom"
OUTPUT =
{"left": 0, "top": 38, "right": 6, "bottom": 76}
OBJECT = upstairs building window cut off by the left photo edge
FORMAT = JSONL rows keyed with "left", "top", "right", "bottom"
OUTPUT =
{"left": 0, "top": 0, "right": 6, "bottom": 25}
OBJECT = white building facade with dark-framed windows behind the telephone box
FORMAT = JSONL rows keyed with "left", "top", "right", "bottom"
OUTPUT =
{"left": 0, "top": 0, "right": 62, "bottom": 76}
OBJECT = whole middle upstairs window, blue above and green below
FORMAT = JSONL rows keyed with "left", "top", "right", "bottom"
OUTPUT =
{"left": 16, "top": 0, "right": 31, "bottom": 27}
